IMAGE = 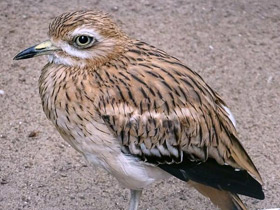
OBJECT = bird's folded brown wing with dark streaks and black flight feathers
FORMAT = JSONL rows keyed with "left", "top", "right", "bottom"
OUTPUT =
{"left": 96, "top": 42, "right": 261, "bottom": 197}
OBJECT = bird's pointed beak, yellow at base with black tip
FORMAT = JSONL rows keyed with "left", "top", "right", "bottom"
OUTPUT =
{"left": 14, "top": 40, "right": 59, "bottom": 60}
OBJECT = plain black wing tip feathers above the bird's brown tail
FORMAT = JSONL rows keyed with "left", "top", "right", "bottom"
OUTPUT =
{"left": 158, "top": 158, "right": 265, "bottom": 200}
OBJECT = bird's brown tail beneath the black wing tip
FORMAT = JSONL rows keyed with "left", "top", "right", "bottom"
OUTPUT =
{"left": 188, "top": 180, "right": 247, "bottom": 210}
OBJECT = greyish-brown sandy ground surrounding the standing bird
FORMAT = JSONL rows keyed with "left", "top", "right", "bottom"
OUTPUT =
{"left": 0, "top": 0, "right": 280, "bottom": 210}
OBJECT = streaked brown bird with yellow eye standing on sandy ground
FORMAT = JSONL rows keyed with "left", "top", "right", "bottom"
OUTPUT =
{"left": 14, "top": 10, "right": 265, "bottom": 210}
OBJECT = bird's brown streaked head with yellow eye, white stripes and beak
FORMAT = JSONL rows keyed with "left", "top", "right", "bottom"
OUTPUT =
{"left": 14, "top": 11, "right": 128, "bottom": 67}
